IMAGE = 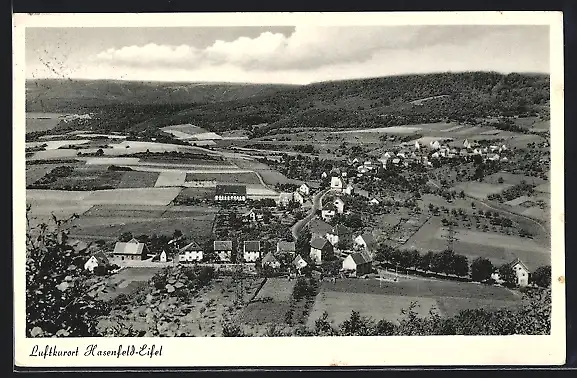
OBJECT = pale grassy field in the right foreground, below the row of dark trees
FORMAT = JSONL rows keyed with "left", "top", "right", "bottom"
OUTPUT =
{"left": 308, "top": 278, "right": 520, "bottom": 326}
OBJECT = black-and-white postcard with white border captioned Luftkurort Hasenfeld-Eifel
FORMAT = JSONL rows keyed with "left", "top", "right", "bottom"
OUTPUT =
{"left": 13, "top": 12, "right": 565, "bottom": 366}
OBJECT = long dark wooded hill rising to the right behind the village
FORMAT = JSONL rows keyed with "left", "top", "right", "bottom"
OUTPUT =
{"left": 29, "top": 72, "right": 549, "bottom": 136}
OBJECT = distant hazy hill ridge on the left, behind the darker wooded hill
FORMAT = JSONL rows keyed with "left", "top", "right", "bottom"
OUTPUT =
{"left": 26, "top": 79, "right": 291, "bottom": 113}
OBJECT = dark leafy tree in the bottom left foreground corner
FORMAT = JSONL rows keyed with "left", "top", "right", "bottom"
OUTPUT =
{"left": 26, "top": 208, "right": 109, "bottom": 337}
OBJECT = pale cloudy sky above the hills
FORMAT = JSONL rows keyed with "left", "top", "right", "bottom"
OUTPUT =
{"left": 25, "top": 25, "right": 549, "bottom": 84}
